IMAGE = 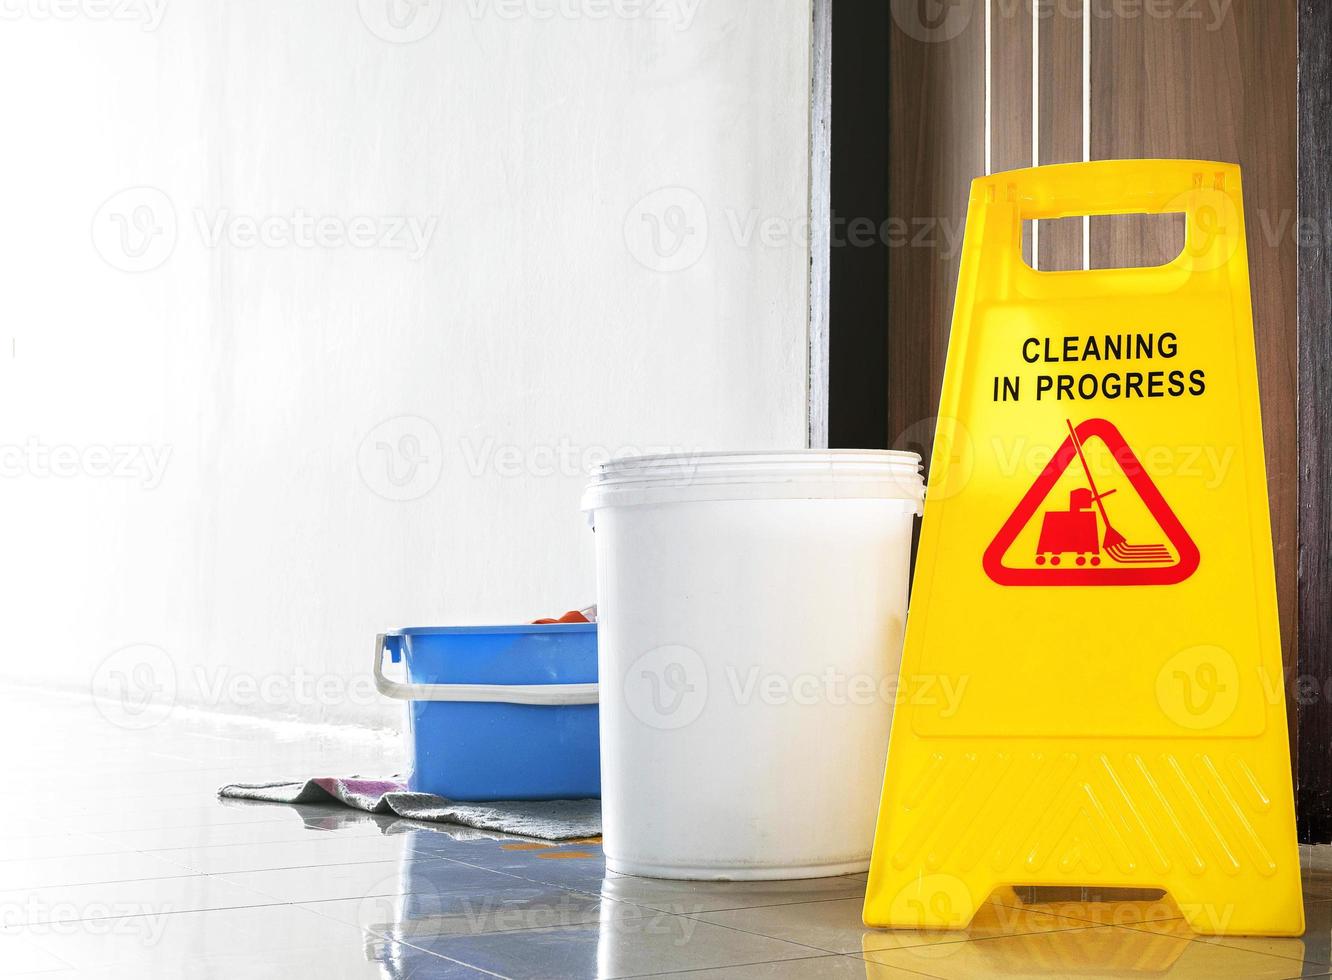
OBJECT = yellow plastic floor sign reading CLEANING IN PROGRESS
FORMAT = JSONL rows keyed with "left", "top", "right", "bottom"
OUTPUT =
{"left": 864, "top": 160, "right": 1304, "bottom": 936}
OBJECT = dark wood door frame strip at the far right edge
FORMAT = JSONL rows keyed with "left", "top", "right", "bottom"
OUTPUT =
{"left": 1295, "top": 0, "right": 1332, "bottom": 844}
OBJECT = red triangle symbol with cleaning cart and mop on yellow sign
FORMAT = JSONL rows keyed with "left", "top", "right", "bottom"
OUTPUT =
{"left": 984, "top": 418, "right": 1199, "bottom": 586}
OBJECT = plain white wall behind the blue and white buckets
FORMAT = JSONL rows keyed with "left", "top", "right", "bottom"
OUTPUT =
{"left": 0, "top": 0, "right": 810, "bottom": 724}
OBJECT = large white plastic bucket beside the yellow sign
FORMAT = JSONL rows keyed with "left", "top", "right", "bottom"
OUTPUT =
{"left": 582, "top": 450, "right": 924, "bottom": 880}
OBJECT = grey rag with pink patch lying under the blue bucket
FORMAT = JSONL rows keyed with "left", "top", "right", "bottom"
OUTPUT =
{"left": 217, "top": 776, "right": 601, "bottom": 840}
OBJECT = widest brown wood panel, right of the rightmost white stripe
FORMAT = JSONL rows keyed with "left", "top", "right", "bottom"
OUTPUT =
{"left": 1091, "top": 0, "right": 1299, "bottom": 697}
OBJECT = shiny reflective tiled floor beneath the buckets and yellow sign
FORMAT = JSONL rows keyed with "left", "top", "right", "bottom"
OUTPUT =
{"left": 0, "top": 691, "right": 1332, "bottom": 980}
